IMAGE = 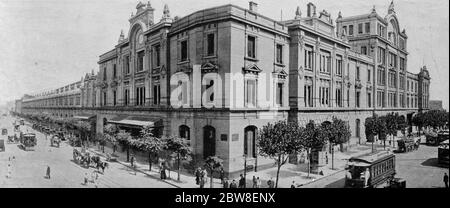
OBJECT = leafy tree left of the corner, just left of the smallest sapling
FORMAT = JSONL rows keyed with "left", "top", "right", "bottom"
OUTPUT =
{"left": 166, "top": 137, "right": 192, "bottom": 181}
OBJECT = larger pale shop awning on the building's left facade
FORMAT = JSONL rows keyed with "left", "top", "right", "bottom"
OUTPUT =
{"left": 108, "top": 116, "right": 162, "bottom": 127}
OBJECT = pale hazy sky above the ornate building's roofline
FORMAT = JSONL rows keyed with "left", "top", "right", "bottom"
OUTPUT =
{"left": 0, "top": 0, "right": 449, "bottom": 110}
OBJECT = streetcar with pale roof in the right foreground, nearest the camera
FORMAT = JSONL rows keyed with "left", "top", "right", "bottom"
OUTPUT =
{"left": 345, "top": 151, "right": 395, "bottom": 188}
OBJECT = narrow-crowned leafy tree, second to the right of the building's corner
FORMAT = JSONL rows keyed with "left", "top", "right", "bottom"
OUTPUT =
{"left": 298, "top": 120, "right": 326, "bottom": 177}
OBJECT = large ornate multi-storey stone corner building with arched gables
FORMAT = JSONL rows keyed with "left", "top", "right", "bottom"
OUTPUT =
{"left": 17, "top": 2, "right": 430, "bottom": 175}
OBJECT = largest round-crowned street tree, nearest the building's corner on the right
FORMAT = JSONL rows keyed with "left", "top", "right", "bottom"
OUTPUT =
{"left": 256, "top": 121, "right": 301, "bottom": 187}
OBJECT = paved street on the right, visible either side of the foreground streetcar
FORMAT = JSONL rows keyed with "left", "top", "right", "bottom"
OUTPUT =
{"left": 303, "top": 145, "right": 449, "bottom": 188}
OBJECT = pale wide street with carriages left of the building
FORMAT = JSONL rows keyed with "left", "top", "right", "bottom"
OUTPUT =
{"left": 0, "top": 117, "right": 173, "bottom": 188}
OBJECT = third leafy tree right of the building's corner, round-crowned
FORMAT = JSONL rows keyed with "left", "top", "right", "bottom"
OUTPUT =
{"left": 318, "top": 117, "right": 351, "bottom": 169}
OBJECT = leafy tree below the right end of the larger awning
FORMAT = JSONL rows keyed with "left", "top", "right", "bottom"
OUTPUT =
{"left": 133, "top": 126, "right": 166, "bottom": 171}
